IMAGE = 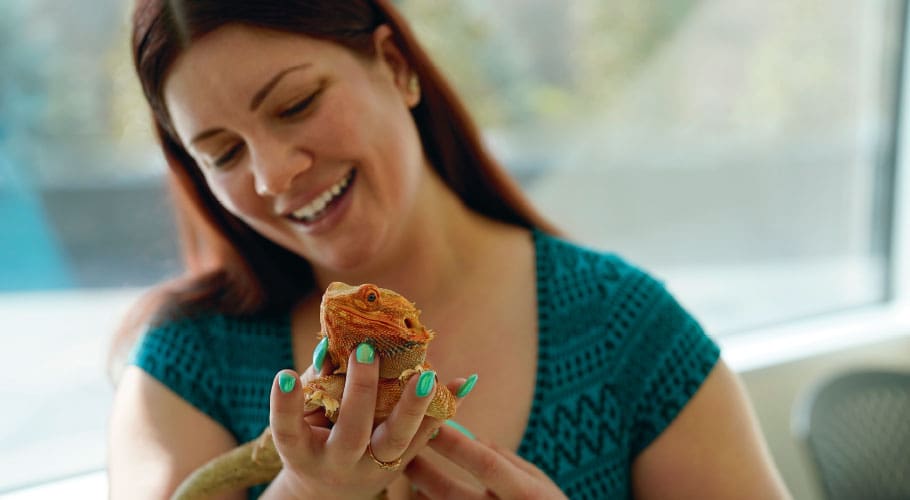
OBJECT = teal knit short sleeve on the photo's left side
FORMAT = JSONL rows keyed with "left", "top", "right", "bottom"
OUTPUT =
{"left": 129, "top": 319, "right": 227, "bottom": 425}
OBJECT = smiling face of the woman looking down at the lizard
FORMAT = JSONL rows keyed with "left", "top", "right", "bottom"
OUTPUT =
{"left": 164, "top": 23, "right": 436, "bottom": 268}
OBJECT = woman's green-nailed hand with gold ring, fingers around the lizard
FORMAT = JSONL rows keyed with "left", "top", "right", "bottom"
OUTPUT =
{"left": 263, "top": 346, "right": 470, "bottom": 498}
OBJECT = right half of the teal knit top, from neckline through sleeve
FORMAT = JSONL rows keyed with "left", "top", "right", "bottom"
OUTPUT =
{"left": 518, "top": 234, "right": 720, "bottom": 499}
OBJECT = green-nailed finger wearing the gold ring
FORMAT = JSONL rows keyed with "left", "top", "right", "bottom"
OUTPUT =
{"left": 370, "top": 370, "right": 436, "bottom": 461}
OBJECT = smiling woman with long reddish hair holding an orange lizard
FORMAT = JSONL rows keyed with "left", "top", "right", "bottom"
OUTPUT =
{"left": 109, "top": 0, "right": 786, "bottom": 498}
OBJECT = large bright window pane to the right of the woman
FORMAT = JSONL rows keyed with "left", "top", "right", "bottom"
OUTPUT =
{"left": 400, "top": 0, "right": 903, "bottom": 336}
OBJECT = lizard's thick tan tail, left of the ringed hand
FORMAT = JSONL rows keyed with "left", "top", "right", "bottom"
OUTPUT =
{"left": 171, "top": 430, "right": 282, "bottom": 500}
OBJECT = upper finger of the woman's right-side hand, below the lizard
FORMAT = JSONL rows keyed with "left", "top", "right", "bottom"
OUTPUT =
{"left": 430, "top": 426, "right": 530, "bottom": 498}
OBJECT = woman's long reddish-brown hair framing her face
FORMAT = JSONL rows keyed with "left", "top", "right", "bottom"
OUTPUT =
{"left": 115, "top": 0, "right": 555, "bottom": 376}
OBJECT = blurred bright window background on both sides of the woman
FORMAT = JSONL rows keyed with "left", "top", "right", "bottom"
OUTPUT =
{"left": 0, "top": 0, "right": 910, "bottom": 499}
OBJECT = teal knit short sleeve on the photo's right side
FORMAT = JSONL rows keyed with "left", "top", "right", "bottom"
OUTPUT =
{"left": 627, "top": 271, "right": 720, "bottom": 457}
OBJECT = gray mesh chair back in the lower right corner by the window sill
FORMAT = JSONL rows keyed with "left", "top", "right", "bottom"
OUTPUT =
{"left": 793, "top": 370, "right": 910, "bottom": 500}
